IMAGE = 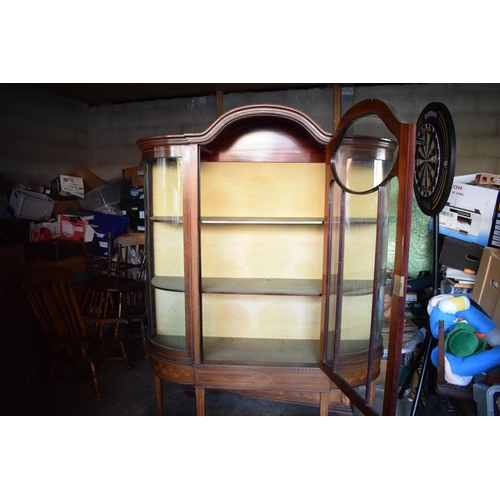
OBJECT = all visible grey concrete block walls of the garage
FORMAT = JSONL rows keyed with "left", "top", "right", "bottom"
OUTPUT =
{"left": 0, "top": 84, "right": 500, "bottom": 191}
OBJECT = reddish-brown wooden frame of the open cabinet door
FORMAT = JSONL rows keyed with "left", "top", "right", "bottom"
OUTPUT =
{"left": 320, "top": 99, "right": 416, "bottom": 415}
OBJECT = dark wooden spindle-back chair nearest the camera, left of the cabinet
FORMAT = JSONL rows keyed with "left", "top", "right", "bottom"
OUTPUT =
{"left": 23, "top": 267, "right": 131, "bottom": 401}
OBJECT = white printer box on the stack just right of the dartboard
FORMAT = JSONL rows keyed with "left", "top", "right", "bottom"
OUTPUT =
{"left": 430, "top": 174, "right": 500, "bottom": 247}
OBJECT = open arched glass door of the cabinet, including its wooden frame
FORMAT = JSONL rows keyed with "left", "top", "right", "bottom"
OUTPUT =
{"left": 322, "top": 101, "right": 414, "bottom": 414}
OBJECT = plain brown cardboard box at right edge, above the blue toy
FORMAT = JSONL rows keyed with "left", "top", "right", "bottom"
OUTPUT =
{"left": 472, "top": 247, "right": 500, "bottom": 325}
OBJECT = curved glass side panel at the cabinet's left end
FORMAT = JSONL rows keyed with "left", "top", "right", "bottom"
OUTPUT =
{"left": 148, "top": 158, "right": 186, "bottom": 349}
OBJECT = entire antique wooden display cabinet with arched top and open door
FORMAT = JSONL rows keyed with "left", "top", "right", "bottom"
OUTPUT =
{"left": 138, "top": 100, "right": 415, "bottom": 415}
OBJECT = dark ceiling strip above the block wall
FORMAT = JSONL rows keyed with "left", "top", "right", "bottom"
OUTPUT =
{"left": 30, "top": 83, "right": 331, "bottom": 106}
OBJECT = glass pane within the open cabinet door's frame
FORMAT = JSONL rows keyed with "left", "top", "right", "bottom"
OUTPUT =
{"left": 325, "top": 117, "right": 398, "bottom": 376}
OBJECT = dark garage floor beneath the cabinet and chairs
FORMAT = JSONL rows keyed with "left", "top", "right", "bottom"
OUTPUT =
{"left": 2, "top": 328, "right": 474, "bottom": 416}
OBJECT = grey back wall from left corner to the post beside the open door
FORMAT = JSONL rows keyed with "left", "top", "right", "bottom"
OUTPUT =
{"left": 89, "top": 88, "right": 333, "bottom": 182}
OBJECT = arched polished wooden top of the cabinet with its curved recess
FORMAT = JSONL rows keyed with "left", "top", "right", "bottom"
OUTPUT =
{"left": 137, "top": 105, "right": 332, "bottom": 162}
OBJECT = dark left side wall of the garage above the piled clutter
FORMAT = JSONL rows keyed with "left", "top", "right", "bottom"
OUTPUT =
{"left": 0, "top": 84, "right": 89, "bottom": 189}
